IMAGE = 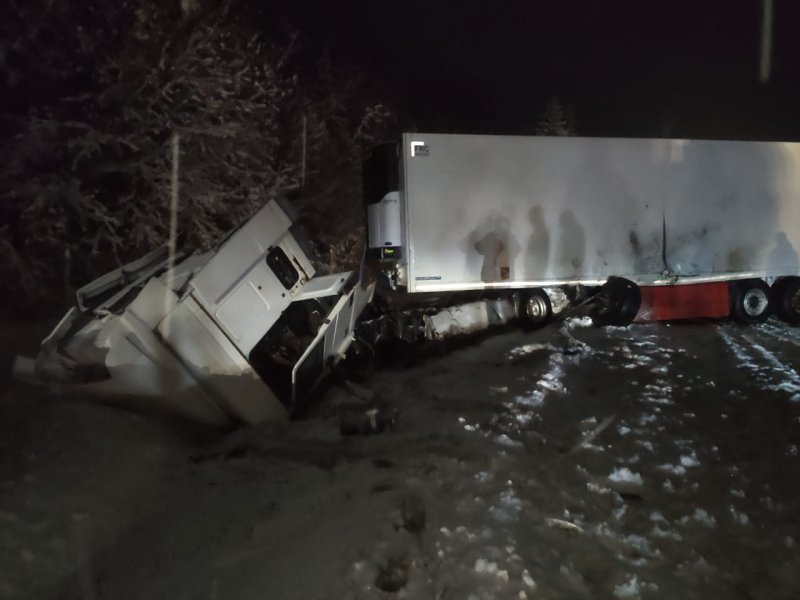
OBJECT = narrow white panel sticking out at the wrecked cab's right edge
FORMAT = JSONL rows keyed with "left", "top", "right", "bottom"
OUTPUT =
{"left": 291, "top": 283, "right": 375, "bottom": 413}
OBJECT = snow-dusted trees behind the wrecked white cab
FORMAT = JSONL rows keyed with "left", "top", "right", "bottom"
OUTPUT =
{"left": 0, "top": 0, "right": 391, "bottom": 312}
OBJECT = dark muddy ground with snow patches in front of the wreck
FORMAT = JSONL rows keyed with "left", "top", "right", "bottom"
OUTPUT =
{"left": 0, "top": 322, "right": 800, "bottom": 599}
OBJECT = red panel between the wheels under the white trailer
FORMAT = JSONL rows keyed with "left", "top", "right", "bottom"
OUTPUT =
{"left": 636, "top": 282, "right": 730, "bottom": 321}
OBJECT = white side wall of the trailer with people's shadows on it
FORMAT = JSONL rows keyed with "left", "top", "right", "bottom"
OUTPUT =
{"left": 401, "top": 133, "right": 800, "bottom": 292}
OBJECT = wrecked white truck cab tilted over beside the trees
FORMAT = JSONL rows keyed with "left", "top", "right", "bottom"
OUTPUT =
{"left": 14, "top": 201, "right": 373, "bottom": 426}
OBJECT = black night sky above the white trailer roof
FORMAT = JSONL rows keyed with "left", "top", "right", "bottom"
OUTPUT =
{"left": 294, "top": 0, "right": 800, "bottom": 139}
